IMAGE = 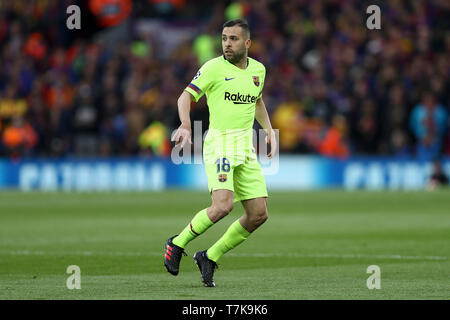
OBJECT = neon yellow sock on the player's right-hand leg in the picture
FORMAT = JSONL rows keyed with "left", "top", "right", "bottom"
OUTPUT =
{"left": 206, "top": 220, "right": 250, "bottom": 262}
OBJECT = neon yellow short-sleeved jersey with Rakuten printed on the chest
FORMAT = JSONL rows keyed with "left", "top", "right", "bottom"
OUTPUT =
{"left": 185, "top": 56, "right": 266, "bottom": 134}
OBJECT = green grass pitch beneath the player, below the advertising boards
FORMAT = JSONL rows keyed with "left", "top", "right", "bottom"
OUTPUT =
{"left": 0, "top": 190, "right": 450, "bottom": 300}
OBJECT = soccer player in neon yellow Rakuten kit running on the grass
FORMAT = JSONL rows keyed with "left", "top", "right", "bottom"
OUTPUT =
{"left": 164, "top": 19, "right": 276, "bottom": 287}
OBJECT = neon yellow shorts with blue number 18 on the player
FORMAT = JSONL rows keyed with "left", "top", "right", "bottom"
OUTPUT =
{"left": 203, "top": 132, "right": 268, "bottom": 202}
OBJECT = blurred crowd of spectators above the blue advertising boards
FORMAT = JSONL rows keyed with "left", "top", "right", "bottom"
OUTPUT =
{"left": 0, "top": 0, "right": 450, "bottom": 160}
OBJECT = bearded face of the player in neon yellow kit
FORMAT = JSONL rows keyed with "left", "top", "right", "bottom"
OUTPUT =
{"left": 222, "top": 26, "right": 250, "bottom": 63}
